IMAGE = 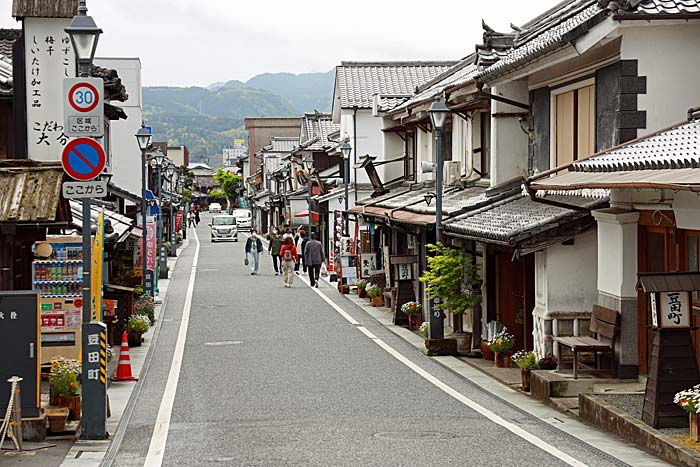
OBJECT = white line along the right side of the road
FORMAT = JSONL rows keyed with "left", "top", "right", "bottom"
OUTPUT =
{"left": 314, "top": 289, "right": 586, "bottom": 467}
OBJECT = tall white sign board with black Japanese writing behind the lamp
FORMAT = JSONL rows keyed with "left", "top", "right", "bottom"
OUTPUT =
{"left": 23, "top": 17, "right": 75, "bottom": 161}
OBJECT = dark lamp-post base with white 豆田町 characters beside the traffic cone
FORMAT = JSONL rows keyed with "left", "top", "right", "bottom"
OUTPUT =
{"left": 81, "top": 322, "right": 107, "bottom": 439}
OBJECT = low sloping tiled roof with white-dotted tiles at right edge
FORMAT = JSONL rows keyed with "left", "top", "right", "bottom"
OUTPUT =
{"left": 570, "top": 120, "right": 700, "bottom": 172}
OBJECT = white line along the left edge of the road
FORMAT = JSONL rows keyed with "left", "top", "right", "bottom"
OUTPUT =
{"left": 143, "top": 229, "right": 200, "bottom": 467}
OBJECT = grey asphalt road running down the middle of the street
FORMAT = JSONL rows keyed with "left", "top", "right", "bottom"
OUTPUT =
{"left": 108, "top": 214, "right": 644, "bottom": 466}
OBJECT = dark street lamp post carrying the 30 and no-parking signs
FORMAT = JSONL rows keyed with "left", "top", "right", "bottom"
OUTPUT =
{"left": 65, "top": 0, "right": 107, "bottom": 439}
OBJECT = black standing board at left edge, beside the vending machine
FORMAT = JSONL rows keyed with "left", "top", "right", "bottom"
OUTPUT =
{"left": 0, "top": 291, "right": 41, "bottom": 418}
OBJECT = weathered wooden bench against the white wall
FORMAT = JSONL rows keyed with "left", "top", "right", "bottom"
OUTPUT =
{"left": 554, "top": 305, "right": 620, "bottom": 379}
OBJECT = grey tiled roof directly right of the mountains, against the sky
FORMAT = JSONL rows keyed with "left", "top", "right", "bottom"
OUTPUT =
{"left": 334, "top": 61, "right": 456, "bottom": 109}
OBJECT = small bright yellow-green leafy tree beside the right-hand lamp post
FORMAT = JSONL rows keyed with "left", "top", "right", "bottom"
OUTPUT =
{"left": 419, "top": 243, "right": 481, "bottom": 353}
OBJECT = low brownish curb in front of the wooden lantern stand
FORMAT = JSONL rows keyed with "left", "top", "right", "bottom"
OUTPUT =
{"left": 578, "top": 394, "right": 700, "bottom": 467}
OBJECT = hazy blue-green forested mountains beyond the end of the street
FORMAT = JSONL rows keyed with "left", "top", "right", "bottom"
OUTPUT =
{"left": 143, "top": 71, "right": 335, "bottom": 162}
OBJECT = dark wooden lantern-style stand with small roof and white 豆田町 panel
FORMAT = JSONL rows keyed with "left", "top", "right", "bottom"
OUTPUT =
{"left": 640, "top": 273, "right": 700, "bottom": 428}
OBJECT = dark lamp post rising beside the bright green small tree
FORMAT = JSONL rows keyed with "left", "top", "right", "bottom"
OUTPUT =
{"left": 428, "top": 98, "right": 449, "bottom": 339}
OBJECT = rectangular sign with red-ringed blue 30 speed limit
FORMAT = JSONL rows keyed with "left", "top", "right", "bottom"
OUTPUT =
{"left": 63, "top": 78, "right": 104, "bottom": 138}
